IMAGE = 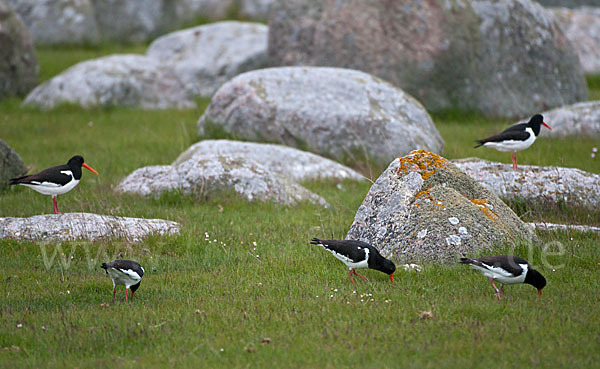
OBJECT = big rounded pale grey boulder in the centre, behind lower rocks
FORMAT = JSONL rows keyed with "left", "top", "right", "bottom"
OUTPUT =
{"left": 198, "top": 67, "right": 444, "bottom": 166}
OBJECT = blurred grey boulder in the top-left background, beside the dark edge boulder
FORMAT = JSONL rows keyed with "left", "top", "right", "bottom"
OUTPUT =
{"left": 9, "top": 0, "right": 100, "bottom": 44}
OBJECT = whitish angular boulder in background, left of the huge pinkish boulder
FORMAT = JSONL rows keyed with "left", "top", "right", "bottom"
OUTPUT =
{"left": 147, "top": 21, "right": 268, "bottom": 97}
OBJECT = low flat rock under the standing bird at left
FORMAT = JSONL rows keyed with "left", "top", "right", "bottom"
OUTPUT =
{"left": 0, "top": 213, "right": 179, "bottom": 242}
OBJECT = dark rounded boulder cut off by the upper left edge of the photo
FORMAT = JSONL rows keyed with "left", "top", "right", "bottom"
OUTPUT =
{"left": 0, "top": 0, "right": 39, "bottom": 100}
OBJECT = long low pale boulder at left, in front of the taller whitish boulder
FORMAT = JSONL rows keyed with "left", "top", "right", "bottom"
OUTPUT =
{"left": 23, "top": 55, "right": 195, "bottom": 109}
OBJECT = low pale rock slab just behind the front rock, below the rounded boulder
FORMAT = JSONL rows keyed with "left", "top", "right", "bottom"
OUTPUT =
{"left": 173, "top": 140, "right": 364, "bottom": 182}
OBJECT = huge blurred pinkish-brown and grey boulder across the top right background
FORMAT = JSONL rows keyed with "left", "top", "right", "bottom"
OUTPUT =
{"left": 269, "top": 0, "right": 587, "bottom": 117}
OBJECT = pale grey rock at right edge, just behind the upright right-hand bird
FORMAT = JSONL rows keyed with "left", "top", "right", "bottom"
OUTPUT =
{"left": 540, "top": 100, "right": 600, "bottom": 138}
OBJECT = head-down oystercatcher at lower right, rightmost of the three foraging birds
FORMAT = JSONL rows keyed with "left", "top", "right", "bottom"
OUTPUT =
{"left": 459, "top": 255, "right": 546, "bottom": 299}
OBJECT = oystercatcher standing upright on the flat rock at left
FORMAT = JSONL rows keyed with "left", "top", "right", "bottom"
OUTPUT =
{"left": 10, "top": 155, "right": 98, "bottom": 214}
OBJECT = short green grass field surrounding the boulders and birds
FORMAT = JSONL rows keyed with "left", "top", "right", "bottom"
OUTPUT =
{"left": 0, "top": 46, "right": 600, "bottom": 368}
